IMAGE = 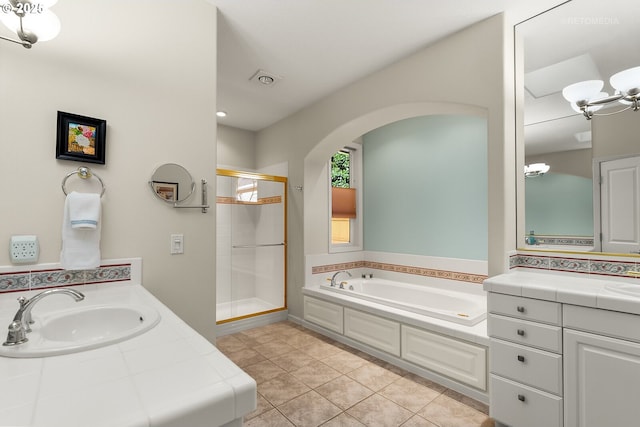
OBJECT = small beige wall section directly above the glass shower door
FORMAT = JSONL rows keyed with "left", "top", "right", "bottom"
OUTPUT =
{"left": 218, "top": 124, "right": 256, "bottom": 171}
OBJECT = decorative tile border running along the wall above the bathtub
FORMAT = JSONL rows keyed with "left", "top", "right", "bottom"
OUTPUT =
{"left": 311, "top": 261, "right": 487, "bottom": 284}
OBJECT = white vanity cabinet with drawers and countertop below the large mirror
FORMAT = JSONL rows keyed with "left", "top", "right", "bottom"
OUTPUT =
{"left": 484, "top": 271, "right": 640, "bottom": 427}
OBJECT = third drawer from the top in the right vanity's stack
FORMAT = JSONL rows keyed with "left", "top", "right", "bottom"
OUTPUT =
{"left": 490, "top": 339, "right": 562, "bottom": 395}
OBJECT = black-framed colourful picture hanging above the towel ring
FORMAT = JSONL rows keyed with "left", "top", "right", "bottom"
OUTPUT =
{"left": 56, "top": 111, "right": 107, "bottom": 165}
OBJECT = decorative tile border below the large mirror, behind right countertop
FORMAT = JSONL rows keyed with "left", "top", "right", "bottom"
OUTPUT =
{"left": 509, "top": 253, "right": 640, "bottom": 278}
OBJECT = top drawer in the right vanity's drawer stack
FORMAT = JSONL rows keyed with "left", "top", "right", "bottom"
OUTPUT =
{"left": 487, "top": 292, "right": 562, "bottom": 325}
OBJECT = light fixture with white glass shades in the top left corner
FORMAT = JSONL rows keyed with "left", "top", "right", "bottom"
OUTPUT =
{"left": 0, "top": 0, "right": 60, "bottom": 49}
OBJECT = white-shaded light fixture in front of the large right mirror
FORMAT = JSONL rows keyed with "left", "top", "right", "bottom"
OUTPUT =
{"left": 562, "top": 67, "right": 640, "bottom": 120}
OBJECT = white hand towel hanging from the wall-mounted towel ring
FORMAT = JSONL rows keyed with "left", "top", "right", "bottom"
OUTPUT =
{"left": 60, "top": 191, "right": 102, "bottom": 270}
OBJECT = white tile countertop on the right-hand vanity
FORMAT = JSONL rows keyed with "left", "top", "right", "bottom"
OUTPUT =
{"left": 483, "top": 270, "right": 640, "bottom": 314}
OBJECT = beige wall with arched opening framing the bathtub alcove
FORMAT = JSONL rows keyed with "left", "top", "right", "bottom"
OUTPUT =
{"left": 256, "top": 15, "right": 515, "bottom": 317}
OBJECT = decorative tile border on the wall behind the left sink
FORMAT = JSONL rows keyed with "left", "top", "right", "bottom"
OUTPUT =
{"left": 0, "top": 264, "right": 131, "bottom": 293}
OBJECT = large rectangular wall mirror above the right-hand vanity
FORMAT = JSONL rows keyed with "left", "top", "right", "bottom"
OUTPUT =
{"left": 515, "top": 0, "right": 640, "bottom": 254}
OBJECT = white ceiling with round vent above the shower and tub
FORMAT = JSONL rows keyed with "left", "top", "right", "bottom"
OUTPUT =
{"left": 209, "top": 0, "right": 563, "bottom": 131}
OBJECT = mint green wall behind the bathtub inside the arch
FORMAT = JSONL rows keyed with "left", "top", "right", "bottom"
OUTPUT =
{"left": 363, "top": 115, "right": 488, "bottom": 260}
